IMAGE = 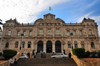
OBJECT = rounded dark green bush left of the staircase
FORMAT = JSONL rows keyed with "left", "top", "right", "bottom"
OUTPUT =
{"left": 3, "top": 49, "right": 17, "bottom": 59}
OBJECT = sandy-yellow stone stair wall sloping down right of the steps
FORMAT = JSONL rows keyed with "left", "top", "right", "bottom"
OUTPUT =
{"left": 71, "top": 51, "right": 92, "bottom": 66}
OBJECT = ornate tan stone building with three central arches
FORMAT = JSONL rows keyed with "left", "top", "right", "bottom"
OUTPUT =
{"left": 1, "top": 13, "right": 100, "bottom": 54}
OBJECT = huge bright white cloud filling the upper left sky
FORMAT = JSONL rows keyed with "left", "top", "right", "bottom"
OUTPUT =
{"left": 0, "top": 0, "right": 69, "bottom": 23}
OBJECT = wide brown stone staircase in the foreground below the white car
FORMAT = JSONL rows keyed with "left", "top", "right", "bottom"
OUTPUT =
{"left": 18, "top": 58, "right": 77, "bottom": 66}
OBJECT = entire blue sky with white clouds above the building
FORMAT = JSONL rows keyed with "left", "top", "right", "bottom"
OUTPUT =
{"left": 0, "top": 0, "right": 100, "bottom": 35}
